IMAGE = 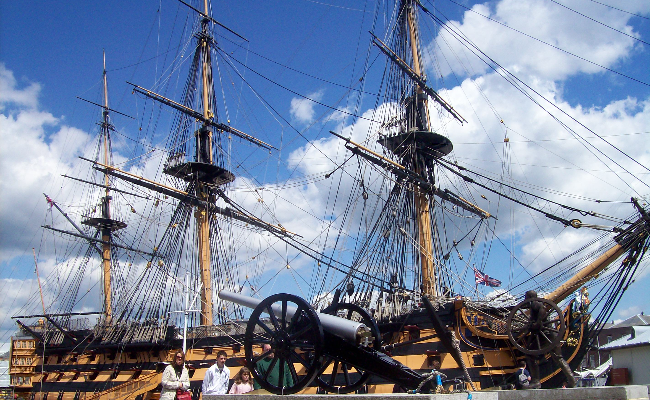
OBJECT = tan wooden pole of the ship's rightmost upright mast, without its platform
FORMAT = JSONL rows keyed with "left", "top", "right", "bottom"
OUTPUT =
{"left": 404, "top": 0, "right": 438, "bottom": 298}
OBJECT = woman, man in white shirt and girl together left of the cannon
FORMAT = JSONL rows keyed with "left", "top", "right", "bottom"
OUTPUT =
{"left": 160, "top": 350, "right": 255, "bottom": 400}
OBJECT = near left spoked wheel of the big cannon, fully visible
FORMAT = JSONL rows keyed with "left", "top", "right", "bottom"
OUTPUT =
{"left": 244, "top": 293, "right": 324, "bottom": 394}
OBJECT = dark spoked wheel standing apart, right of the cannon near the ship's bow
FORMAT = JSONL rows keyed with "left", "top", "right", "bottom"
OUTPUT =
{"left": 508, "top": 297, "right": 566, "bottom": 356}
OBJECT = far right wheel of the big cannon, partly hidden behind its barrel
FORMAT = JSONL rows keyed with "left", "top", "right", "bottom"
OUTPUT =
{"left": 316, "top": 303, "right": 381, "bottom": 394}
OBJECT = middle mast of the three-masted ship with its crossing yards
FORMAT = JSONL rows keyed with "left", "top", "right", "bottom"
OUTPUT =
{"left": 123, "top": 0, "right": 273, "bottom": 326}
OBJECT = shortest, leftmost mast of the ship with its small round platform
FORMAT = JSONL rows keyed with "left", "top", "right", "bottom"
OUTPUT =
{"left": 82, "top": 52, "right": 126, "bottom": 324}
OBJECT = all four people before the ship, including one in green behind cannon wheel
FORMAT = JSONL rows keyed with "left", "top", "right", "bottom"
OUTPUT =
{"left": 160, "top": 344, "right": 293, "bottom": 400}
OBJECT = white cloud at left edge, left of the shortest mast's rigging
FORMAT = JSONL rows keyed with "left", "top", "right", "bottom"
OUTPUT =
{"left": 0, "top": 79, "right": 90, "bottom": 260}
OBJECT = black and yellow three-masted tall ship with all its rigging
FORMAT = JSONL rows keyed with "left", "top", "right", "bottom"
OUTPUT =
{"left": 11, "top": 0, "right": 650, "bottom": 400}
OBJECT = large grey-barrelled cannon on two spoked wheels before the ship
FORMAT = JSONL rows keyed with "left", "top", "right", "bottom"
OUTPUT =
{"left": 219, "top": 291, "right": 436, "bottom": 394}
